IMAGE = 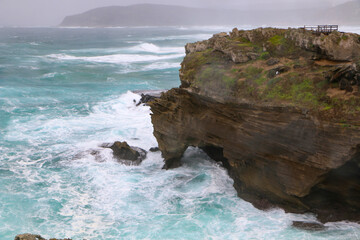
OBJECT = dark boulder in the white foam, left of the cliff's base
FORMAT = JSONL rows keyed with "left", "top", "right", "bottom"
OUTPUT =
{"left": 101, "top": 142, "right": 146, "bottom": 165}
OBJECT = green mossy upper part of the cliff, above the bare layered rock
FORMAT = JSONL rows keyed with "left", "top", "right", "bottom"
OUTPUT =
{"left": 180, "top": 28, "right": 360, "bottom": 126}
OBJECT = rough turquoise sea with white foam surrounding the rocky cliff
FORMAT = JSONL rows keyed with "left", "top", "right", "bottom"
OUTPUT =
{"left": 0, "top": 28, "right": 360, "bottom": 240}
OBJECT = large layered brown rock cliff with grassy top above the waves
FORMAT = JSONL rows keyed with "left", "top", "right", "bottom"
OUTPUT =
{"left": 150, "top": 28, "right": 360, "bottom": 222}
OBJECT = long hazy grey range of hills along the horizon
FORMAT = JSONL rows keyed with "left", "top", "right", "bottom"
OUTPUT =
{"left": 60, "top": 0, "right": 360, "bottom": 27}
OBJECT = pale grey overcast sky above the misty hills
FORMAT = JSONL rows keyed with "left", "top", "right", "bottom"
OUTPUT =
{"left": 0, "top": 0, "right": 348, "bottom": 26}
